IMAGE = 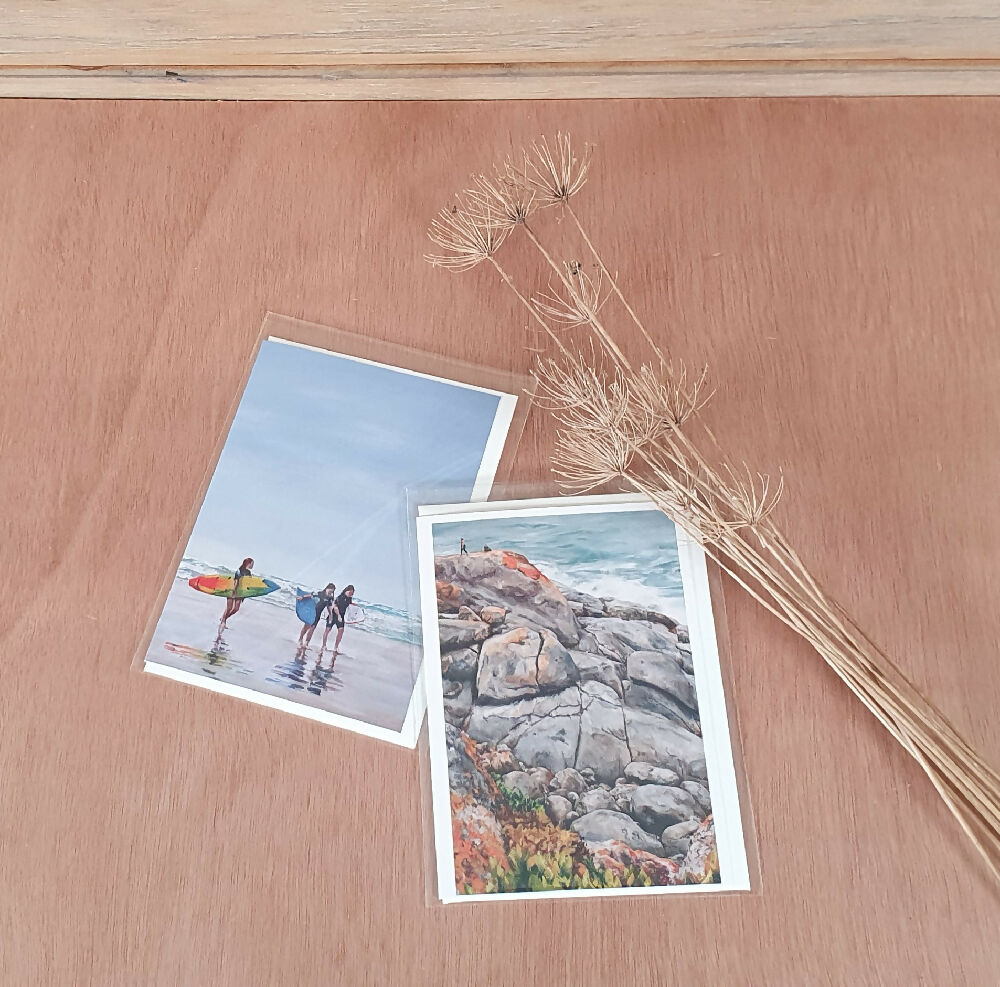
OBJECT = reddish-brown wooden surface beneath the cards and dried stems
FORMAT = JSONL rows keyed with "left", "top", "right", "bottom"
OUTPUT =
{"left": 0, "top": 99, "right": 1000, "bottom": 987}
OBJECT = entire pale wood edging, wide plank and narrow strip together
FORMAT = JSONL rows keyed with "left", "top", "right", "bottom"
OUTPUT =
{"left": 0, "top": 0, "right": 1000, "bottom": 99}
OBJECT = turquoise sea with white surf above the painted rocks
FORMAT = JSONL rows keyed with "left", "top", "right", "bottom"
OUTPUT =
{"left": 434, "top": 511, "right": 686, "bottom": 622}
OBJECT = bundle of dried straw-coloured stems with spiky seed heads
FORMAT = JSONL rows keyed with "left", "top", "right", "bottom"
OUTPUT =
{"left": 427, "top": 134, "right": 1000, "bottom": 880}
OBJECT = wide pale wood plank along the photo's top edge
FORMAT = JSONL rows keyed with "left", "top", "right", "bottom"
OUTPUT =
{"left": 0, "top": 0, "right": 1000, "bottom": 65}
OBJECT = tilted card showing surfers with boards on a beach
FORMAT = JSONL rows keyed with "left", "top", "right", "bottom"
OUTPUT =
{"left": 144, "top": 338, "right": 517, "bottom": 746}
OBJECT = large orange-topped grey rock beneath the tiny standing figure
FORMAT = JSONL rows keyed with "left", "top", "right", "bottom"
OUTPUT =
{"left": 434, "top": 551, "right": 580, "bottom": 647}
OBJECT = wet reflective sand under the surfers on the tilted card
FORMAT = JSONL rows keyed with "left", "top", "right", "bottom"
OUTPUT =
{"left": 146, "top": 577, "right": 416, "bottom": 731}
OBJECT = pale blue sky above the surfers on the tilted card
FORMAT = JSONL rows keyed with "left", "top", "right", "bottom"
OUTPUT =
{"left": 185, "top": 341, "right": 508, "bottom": 609}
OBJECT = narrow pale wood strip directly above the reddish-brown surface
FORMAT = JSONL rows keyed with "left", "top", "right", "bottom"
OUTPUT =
{"left": 9, "top": 59, "right": 1000, "bottom": 100}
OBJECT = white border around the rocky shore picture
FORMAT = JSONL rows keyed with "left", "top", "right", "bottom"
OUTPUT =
{"left": 416, "top": 494, "right": 751, "bottom": 903}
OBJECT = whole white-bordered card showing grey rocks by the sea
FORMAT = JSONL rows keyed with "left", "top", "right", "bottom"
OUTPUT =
{"left": 417, "top": 497, "right": 749, "bottom": 901}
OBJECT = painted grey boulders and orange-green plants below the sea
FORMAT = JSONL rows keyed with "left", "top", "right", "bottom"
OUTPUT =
{"left": 434, "top": 542, "right": 720, "bottom": 895}
